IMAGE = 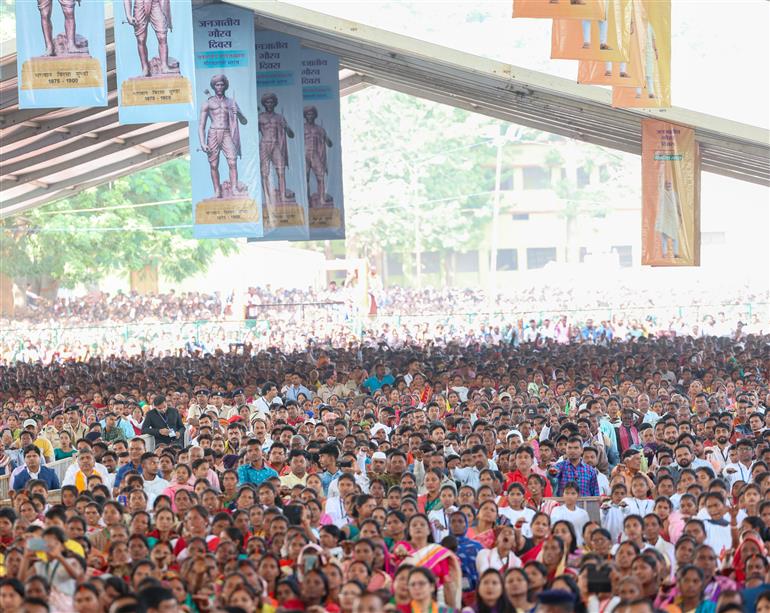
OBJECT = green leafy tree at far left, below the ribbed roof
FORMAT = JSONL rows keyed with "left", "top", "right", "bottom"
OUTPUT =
{"left": 0, "top": 159, "right": 237, "bottom": 293}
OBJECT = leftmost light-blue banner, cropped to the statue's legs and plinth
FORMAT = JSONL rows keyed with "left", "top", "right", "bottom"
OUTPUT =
{"left": 16, "top": 0, "right": 107, "bottom": 109}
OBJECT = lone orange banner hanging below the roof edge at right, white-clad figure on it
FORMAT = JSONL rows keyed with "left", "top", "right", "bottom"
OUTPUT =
{"left": 642, "top": 119, "right": 700, "bottom": 266}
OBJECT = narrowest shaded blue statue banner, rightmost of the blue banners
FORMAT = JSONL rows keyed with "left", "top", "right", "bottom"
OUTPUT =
{"left": 302, "top": 48, "right": 345, "bottom": 240}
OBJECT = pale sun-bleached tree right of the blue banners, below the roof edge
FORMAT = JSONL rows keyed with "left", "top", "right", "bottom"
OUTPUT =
{"left": 342, "top": 87, "right": 500, "bottom": 280}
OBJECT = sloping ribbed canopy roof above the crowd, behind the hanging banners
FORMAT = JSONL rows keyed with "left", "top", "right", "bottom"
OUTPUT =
{"left": 0, "top": 0, "right": 770, "bottom": 218}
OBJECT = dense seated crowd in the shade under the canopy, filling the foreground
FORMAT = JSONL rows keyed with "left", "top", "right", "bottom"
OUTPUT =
{"left": 0, "top": 318, "right": 770, "bottom": 613}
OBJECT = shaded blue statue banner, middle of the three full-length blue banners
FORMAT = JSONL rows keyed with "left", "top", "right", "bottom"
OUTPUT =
{"left": 255, "top": 30, "right": 308, "bottom": 240}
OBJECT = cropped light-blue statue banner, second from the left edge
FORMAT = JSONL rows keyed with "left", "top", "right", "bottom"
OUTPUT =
{"left": 112, "top": 0, "right": 198, "bottom": 124}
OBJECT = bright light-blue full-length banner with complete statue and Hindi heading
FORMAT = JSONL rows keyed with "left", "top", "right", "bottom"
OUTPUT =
{"left": 190, "top": 4, "right": 262, "bottom": 238}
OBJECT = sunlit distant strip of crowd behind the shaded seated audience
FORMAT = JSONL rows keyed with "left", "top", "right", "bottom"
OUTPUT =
{"left": 0, "top": 284, "right": 770, "bottom": 364}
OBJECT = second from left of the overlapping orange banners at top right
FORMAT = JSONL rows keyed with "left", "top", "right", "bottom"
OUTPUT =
{"left": 551, "top": 0, "right": 634, "bottom": 62}
